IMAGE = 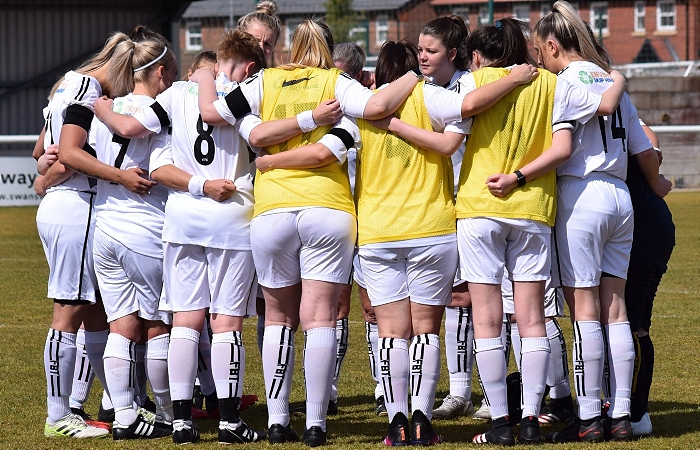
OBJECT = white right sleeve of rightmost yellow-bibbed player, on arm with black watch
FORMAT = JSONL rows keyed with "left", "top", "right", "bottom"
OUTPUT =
{"left": 552, "top": 77, "right": 602, "bottom": 125}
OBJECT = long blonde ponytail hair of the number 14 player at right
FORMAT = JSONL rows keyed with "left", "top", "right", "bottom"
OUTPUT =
{"left": 534, "top": 0, "right": 611, "bottom": 72}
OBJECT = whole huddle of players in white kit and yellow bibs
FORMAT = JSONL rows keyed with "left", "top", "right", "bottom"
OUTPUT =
{"left": 34, "top": 1, "right": 673, "bottom": 447}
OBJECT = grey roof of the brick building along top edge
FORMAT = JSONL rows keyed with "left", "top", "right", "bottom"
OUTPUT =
{"left": 182, "top": 0, "right": 411, "bottom": 19}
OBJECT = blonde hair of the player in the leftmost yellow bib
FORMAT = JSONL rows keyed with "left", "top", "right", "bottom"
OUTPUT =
{"left": 280, "top": 19, "right": 335, "bottom": 70}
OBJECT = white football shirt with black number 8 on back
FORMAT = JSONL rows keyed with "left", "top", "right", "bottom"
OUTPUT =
{"left": 134, "top": 75, "right": 253, "bottom": 250}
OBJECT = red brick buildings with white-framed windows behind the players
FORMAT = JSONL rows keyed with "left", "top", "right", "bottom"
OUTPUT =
{"left": 180, "top": 0, "right": 700, "bottom": 68}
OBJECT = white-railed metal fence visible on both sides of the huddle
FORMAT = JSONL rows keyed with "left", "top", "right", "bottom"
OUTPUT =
{"left": 5, "top": 125, "right": 700, "bottom": 189}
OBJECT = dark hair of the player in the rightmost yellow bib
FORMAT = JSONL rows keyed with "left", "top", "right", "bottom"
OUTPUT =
{"left": 467, "top": 19, "right": 535, "bottom": 67}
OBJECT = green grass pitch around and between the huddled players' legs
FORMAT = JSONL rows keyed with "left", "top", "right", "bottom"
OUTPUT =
{"left": 0, "top": 192, "right": 700, "bottom": 450}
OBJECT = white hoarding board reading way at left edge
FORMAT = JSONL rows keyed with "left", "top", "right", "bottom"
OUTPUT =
{"left": 0, "top": 156, "right": 41, "bottom": 206}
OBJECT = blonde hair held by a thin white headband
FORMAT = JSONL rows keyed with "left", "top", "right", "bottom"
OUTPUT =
{"left": 107, "top": 39, "right": 176, "bottom": 97}
